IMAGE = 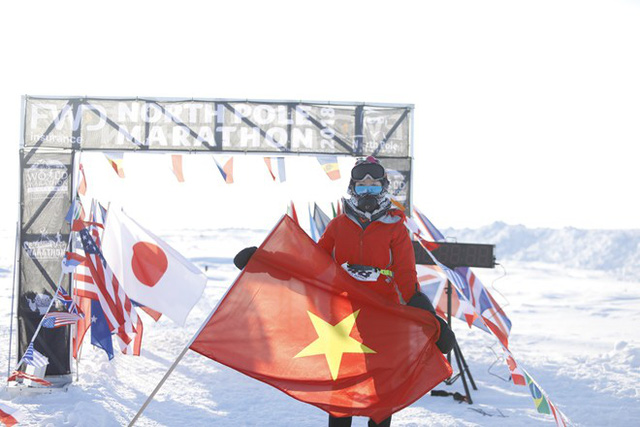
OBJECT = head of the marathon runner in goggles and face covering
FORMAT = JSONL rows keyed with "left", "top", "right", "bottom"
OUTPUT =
{"left": 348, "top": 156, "right": 389, "bottom": 213}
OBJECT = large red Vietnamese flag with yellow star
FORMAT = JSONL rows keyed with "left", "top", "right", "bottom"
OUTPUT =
{"left": 190, "top": 216, "right": 452, "bottom": 422}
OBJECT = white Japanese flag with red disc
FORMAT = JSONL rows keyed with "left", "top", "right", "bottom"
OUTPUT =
{"left": 102, "top": 209, "right": 207, "bottom": 325}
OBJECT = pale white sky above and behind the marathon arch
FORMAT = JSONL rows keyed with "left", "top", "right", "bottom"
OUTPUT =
{"left": 0, "top": 0, "right": 640, "bottom": 229}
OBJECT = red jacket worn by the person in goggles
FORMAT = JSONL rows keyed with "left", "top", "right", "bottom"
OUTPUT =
{"left": 318, "top": 209, "right": 418, "bottom": 303}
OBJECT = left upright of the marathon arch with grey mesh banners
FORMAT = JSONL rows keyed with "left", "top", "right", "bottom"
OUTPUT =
{"left": 18, "top": 149, "right": 72, "bottom": 375}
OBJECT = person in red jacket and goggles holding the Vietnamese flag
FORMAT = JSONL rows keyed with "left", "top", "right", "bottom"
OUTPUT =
{"left": 234, "top": 156, "right": 455, "bottom": 427}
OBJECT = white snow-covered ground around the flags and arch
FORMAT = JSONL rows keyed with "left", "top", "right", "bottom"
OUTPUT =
{"left": 0, "top": 229, "right": 640, "bottom": 427}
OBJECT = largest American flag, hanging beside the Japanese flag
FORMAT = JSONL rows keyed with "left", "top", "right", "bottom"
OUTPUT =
{"left": 78, "top": 216, "right": 142, "bottom": 355}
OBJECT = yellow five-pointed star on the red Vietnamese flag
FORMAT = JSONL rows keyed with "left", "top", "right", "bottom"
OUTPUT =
{"left": 294, "top": 310, "right": 375, "bottom": 381}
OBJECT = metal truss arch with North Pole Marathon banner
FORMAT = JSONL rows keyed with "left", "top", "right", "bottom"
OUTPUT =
{"left": 15, "top": 96, "right": 413, "bottom": 378}
